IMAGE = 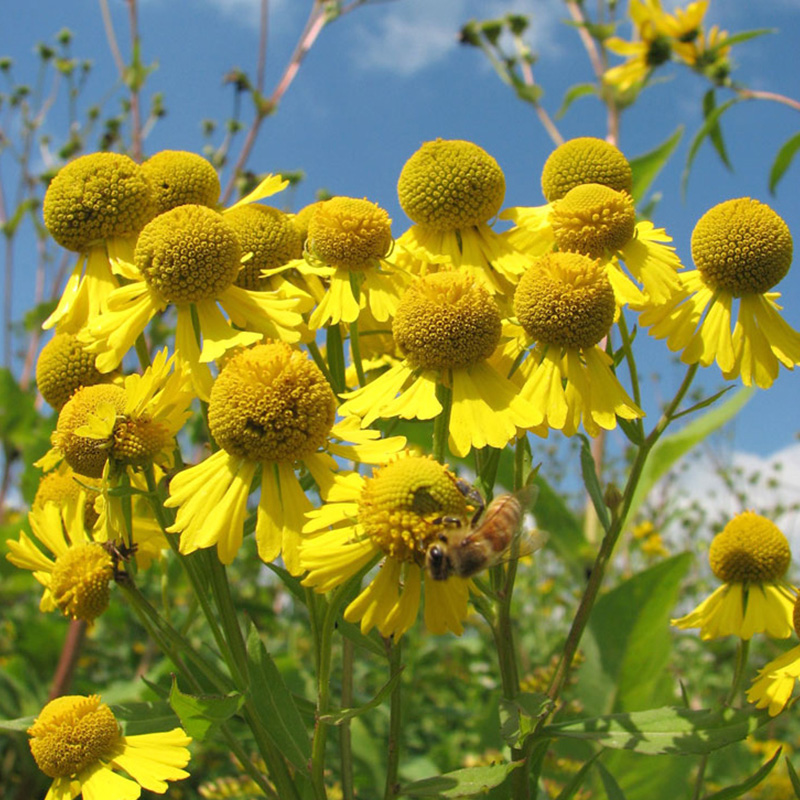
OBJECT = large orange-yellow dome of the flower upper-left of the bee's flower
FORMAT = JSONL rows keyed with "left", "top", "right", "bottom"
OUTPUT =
{"left": 208, "top": 342, "right": 336, "bottom": 463}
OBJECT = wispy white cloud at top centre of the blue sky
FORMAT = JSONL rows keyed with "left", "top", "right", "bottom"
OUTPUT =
{"left": 353, "top": 0, "right": 563, "bottom": 75}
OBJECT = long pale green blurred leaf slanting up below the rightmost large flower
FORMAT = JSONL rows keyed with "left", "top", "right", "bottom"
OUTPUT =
{"left": 628, "top": 387, "right": 755, "bottom": 519}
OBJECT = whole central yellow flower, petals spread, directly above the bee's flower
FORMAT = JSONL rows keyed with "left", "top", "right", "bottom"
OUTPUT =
{"left": 340, "top": 271, "right": 534, "bottom": 456}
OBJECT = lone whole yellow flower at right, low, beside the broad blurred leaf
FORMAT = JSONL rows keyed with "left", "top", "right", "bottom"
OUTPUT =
{"left": 672, "top": 511, "right": 797, "bottom": 639}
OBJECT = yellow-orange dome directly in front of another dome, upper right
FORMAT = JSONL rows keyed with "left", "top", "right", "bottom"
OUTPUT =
{"left": 550, "top": 183, "right": 636, "bottom": 258}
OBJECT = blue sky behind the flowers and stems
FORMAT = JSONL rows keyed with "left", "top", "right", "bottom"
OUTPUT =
{"left": 0, "top": 0, "right": 800, "bottom": 455}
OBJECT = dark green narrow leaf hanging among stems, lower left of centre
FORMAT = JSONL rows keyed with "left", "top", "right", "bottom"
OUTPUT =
{"left": 247, "top": 623, "right": 311, "bottom": 774}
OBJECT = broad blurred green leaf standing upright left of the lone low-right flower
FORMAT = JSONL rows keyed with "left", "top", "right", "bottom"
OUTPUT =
{"left": 584, "top": 553, "right": 692, "bottom": 713}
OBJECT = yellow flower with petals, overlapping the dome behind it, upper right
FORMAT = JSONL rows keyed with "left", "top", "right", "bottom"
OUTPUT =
{"left": 501, "top": 178, "right": 683, "bottom": 310}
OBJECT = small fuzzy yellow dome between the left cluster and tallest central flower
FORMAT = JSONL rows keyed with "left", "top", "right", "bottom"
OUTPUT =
{"left": 306, "top": 197, "right": 392, "bottom": 270}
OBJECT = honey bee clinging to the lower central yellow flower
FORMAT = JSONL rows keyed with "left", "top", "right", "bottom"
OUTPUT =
{"left": 425, "top": 486, "right": 546, "bottom": 581}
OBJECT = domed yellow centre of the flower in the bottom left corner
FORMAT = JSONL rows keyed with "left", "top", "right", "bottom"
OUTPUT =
{"left": 28, "top": 695, "right": 121, "bottom": 778}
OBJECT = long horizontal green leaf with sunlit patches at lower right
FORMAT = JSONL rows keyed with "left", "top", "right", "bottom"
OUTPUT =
{"left": 542, "top": 706, "right": 770, "bottom": 756}
